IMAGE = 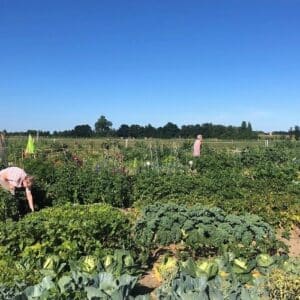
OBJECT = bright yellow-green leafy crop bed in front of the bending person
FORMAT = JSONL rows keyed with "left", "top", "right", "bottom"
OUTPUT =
{"left": 0, "top": 204, "right": 132, "bottom": 283}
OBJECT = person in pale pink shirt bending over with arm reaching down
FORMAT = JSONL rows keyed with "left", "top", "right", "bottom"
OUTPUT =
{"left": 0, "top": 167, "right": 34, "bottom": 211}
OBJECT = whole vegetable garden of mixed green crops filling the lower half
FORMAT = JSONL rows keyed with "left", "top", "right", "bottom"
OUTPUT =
{"left": 0, "top": 141, "right": 300, "bottom": 300}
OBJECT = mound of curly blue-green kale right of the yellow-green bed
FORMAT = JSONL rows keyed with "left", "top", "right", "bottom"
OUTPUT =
{"left": 135, "top": 204, "right": 281, "bottom": 257}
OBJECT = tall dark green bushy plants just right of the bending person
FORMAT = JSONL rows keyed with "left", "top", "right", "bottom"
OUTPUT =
{"left": 24, "top": 159, "right": 131, "bottom": 208}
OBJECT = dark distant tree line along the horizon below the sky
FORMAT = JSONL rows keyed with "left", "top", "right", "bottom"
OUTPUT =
{"left": 2, "top": 116, "right": 300, "bottom": 139}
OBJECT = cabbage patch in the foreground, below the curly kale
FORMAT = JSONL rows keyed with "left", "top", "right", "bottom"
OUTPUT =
{"left": 155, "top": 252, "right": 283, "bottom": 300}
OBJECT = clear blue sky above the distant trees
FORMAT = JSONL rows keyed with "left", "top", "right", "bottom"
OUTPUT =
{"left": 0, "top": 0, "right": 300, "bottom": 131}
